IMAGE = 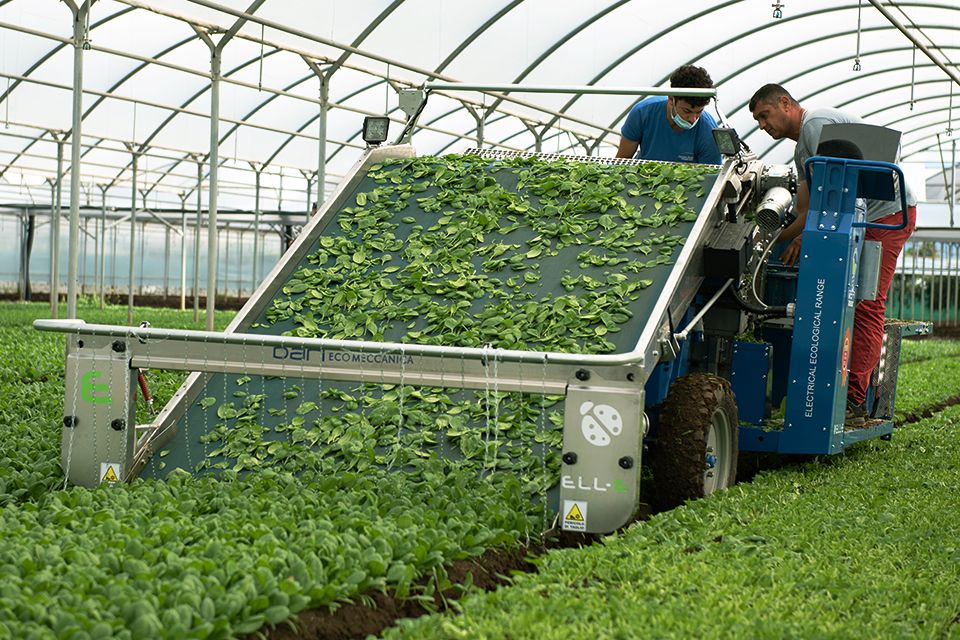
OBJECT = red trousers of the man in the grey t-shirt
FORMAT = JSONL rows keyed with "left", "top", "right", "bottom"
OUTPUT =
{"left": 847, "top": 207, "right": 917, "bottom": 404}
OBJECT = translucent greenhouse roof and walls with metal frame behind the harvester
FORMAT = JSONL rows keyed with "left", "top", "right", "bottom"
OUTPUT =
{"left": 0, "top": 0, "right": 960, "bottom": 328}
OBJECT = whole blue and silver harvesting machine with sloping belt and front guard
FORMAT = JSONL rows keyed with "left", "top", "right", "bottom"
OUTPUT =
{"left": 35, "top": 85, "right": 929, "bottom": 532}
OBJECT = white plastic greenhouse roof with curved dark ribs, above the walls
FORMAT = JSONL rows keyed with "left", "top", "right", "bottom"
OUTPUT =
{"left": 0, "top": 0, "right": 960, "bottom": 211}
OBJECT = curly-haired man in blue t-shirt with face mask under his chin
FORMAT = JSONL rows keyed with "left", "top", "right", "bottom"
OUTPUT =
{"left": 617, "top": 64, "right": 721, "bottom": 164}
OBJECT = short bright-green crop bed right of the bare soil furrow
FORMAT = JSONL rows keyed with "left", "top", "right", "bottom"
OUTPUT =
{"left": 384, "top": 408, "right": 960, "bottom": 640}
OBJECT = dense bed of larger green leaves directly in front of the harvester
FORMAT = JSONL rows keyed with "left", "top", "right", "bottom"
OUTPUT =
{"left": 0, "top": 463, "right": 539, "bottom": 639}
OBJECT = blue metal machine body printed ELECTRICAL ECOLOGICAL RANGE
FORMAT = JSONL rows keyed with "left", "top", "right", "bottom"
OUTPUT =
{"left": 731, "top": 156, "right": 907, "bottom": 454}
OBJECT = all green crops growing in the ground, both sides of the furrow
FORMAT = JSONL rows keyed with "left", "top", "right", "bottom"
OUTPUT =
{"left": 0, "top": 304, "right": 960, "bottom": 638}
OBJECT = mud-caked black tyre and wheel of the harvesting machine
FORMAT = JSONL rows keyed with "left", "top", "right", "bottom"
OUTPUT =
{"left": 652, "top": 373, "right": 739, "bottom": 511}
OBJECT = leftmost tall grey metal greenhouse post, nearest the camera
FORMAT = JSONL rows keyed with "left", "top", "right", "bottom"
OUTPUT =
{"left": 64, "top": 0, "right": 95, "bottom": 318}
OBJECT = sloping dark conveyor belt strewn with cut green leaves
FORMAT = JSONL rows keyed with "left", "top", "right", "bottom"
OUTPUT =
{"left": 141, "top": 151, "right": 716, "bottom": 500}
